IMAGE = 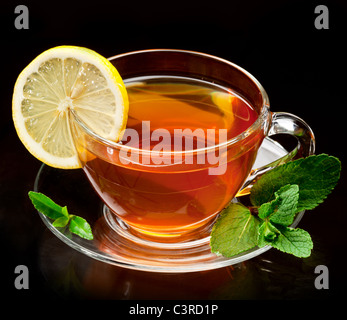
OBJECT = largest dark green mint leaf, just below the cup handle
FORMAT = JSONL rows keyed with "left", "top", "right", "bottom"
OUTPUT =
{"left": 250, "top": 154, "right": 341, "bottom": 212}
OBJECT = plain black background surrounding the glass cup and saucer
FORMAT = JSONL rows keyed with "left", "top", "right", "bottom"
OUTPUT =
{"left": 0, "top": 0, "right": 347, "bottom": 301}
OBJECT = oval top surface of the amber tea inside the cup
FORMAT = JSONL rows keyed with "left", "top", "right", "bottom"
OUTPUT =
{"left": 126, "top": 77, "right": 257, "bottom": 151}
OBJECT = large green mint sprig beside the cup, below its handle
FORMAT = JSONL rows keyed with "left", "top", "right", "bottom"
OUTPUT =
{"left": 210, "top": 154, "right": 341, "bottom": 257}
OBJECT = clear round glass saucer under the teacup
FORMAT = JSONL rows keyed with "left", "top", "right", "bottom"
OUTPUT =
{"left": 34, "top": 138, "right": 303, "bottom": 273}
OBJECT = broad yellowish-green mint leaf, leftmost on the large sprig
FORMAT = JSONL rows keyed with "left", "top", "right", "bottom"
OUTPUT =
{"left": 210, "top": 203, "right": 259, "bottom": 257}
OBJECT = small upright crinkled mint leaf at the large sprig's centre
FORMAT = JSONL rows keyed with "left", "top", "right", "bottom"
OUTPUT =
{"left": 258, "top": 184, "right": 299, "bottom": 226}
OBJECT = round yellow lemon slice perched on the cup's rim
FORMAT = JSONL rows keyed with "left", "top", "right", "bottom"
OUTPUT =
{"left": 12, "top": 46, "right": 129, "bottom": 169}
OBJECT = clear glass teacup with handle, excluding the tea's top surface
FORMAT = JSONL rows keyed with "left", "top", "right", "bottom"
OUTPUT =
{"left": 72, "top": 49, "right": 315, "bottom": 247}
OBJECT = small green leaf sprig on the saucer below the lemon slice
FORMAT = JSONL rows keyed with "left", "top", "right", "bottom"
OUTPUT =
{"left": 29, "top": 191, "right": 94, "bottom": 240}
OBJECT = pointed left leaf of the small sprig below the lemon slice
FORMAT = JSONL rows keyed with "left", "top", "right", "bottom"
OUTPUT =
{"left": 29, "top": 191, "right": 65, "bottom": 220}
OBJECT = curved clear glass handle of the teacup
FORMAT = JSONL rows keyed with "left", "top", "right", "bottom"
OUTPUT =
{"left": 236, "top": 112, "right": 316, "bottom": 197}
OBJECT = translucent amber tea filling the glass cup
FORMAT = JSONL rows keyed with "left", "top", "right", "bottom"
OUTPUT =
{"left": 79, "top": 76, "right": 263, "bottom": 236}
